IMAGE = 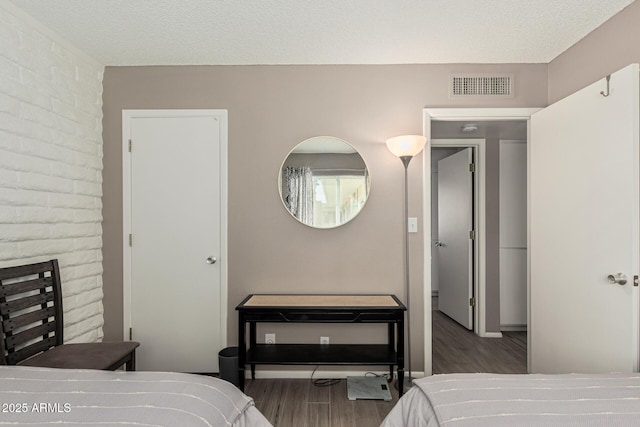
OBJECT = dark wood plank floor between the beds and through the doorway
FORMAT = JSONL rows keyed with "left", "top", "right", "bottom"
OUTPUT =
{"left": 245, "top": 302, "right": 527, "bottom": 427}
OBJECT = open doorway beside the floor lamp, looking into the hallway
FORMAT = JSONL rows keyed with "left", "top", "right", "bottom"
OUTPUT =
{"left": 425, "top": 110, "right": 528, "bottom": 373}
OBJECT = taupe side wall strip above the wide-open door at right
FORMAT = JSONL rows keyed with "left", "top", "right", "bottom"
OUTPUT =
{"left": 549, "top": 0, "right": 640, "bottom": 104}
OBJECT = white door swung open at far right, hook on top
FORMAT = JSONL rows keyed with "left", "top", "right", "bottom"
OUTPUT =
{"left": 529, "top": 64, "right": 640, "bottom": 373}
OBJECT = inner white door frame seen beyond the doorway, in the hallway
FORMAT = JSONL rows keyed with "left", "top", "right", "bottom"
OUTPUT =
{"left": 425, "top": 142, "right": 480, "bottom": 332}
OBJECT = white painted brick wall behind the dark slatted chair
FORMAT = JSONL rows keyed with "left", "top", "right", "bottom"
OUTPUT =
{"left": 0, "top": 0, "right": 104, "bottom": 342}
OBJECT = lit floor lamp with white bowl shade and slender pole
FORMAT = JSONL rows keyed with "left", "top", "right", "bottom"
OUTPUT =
{"left": 387, "top": 135, "right": 427, "bottom": 389}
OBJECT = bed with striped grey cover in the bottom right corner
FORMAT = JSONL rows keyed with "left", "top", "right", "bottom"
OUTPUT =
{"left": 381, "top": 374, "right": 640, "bottom": 427}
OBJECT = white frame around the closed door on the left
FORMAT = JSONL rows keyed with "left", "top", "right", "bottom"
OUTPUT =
{"left": 122, "top": 109, "right": 229, "bottom": 347}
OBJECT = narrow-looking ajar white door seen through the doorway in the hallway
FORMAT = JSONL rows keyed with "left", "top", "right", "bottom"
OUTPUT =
{"left": 435, "top": 148, "right": 473, "bottom": 329}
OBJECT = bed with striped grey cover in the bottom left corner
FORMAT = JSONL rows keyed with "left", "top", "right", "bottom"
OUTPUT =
{"left": 0, "top": 366, "right": 271, "bottom": 427}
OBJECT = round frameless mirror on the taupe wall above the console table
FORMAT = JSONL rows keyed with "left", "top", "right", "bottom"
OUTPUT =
{"left": 278, "top": 136, "right": 370, "bottom": 228}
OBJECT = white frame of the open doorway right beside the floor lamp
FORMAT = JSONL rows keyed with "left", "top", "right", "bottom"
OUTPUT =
{"left": 422, "top": 108, "right": 540, "bottom": 375}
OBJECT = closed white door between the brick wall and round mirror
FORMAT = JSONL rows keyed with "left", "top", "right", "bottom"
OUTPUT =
{"left": 123, "top": 111, "right": 226, "bottom": 372}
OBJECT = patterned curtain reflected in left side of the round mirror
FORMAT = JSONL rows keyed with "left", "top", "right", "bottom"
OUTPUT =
{"left": 282, "top": 166, "right": 313, "bottom": 224}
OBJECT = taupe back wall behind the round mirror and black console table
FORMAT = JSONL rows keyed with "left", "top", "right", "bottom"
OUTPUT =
{"left": 103, "top": 64, "right": 547, "bottom": 370}
